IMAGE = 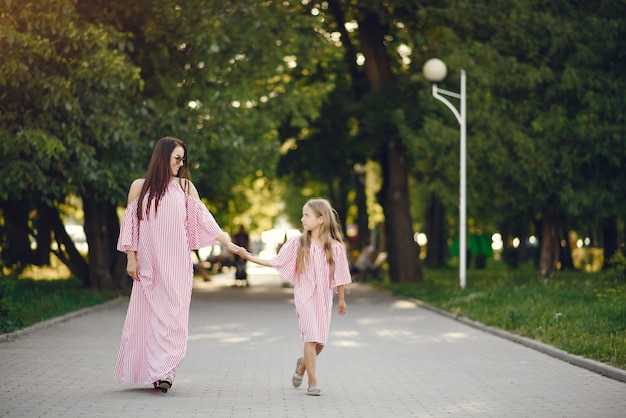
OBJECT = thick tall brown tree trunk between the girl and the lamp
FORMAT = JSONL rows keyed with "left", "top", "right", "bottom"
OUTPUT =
{"left": 359, "top": 11, "right": 422, "bottom": 283}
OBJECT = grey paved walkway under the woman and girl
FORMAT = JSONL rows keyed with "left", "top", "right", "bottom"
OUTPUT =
{"left": 0, "top": 268, "right": 626, "bottom": 418}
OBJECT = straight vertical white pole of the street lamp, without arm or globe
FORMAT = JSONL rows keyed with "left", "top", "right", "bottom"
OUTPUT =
{"left": 459, "top": 70, "right": 467, "bottom": 289}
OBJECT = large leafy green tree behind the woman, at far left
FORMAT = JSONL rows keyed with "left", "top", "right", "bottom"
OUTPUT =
{"left": 2, "top": 0, "right": 342, "bottom": 288}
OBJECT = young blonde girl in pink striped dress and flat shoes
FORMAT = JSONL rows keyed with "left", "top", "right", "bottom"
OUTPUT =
{"left": 244, "top": 199, "right": 351, "bottom": 396}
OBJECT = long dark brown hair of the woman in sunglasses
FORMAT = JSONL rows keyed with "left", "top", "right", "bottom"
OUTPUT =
{"left": 137, "top": 136, "right": 190, "bottom": 219}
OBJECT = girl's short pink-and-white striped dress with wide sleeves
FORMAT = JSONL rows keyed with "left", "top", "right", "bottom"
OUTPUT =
{"left": 272, "top": 237, "right": 352, "bottom": 344}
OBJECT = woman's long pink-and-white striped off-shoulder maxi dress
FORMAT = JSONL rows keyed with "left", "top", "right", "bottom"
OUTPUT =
{"left": 114, "top": 179, "right": 222, "bottom": 384}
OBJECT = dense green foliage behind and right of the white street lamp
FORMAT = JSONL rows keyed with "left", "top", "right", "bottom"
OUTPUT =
{"left": 394, "top": 0, "right": 626, "bottom": 250}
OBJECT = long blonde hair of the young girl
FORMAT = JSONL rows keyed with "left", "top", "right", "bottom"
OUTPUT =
{"left": 296, "top": 199, "right": 343, "bottom": 279}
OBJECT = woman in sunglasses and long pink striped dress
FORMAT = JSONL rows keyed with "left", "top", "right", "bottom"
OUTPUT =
{"left": 115, "top": 137, "right": 243, "bottom": 392}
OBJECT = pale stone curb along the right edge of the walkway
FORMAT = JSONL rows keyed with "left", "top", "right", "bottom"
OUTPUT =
{"left": 408, "top": 298, "right": 626, "bottom": 383}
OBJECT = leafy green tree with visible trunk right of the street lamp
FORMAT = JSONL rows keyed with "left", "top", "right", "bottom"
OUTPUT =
{"left": 428, "top": 0, "right": 624, "bottom": 277}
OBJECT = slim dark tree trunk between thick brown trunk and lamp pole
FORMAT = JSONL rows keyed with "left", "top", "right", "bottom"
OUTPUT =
{"left": 424, "top": 195, "right": 448, "bottom": 268}
